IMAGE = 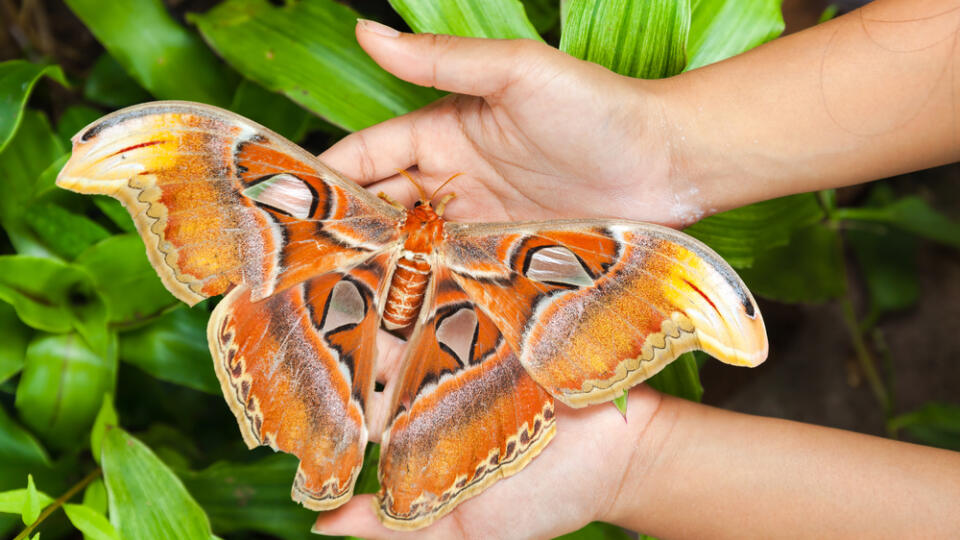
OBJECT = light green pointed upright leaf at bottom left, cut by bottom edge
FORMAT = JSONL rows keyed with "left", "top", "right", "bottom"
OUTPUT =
{"left": 101, "top": 428, "right": 212, "bottom": 539}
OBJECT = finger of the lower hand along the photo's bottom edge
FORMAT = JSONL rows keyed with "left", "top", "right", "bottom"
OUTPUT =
{"left": 312, "top": 495, "right": 458, "bottom": 540}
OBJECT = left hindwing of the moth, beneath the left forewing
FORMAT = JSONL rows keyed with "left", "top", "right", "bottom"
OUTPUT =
{"left": 207, "top": 254, "right": 393, "bottom": 510}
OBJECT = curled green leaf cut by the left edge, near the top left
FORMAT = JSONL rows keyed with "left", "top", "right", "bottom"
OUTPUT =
{"left": 0, "top": 60, "right": 69, "bottom": 152}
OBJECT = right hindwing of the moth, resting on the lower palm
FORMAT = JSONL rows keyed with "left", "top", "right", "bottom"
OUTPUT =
{"left": 377, "top": 266, "right": 555, "bottom": 529}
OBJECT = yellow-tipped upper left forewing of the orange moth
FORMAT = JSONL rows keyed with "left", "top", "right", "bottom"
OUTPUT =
{"left": 57, "top": 101, "right": 402, "bottom": 304}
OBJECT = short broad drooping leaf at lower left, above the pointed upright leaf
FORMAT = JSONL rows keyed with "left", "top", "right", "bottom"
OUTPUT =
{"left": 16, "top": 334, "right": 117, "bottom": 448}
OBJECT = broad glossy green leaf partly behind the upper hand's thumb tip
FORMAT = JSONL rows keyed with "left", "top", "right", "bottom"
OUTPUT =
{"left": 188, "top": 0, "right": 441, "bottom": 131}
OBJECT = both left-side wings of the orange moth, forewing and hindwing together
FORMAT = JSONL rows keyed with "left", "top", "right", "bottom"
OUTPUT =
{"left": 57, "top": 102, "right": 402, "bottom": 509}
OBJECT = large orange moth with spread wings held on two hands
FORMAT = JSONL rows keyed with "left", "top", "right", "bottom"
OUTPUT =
{"left": 57, "top": 102, "right": 767, "bottom": 529}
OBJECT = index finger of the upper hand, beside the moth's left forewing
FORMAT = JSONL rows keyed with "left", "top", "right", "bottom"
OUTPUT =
{"left": 319, "top": 109, "right": 429, "bottom": 186}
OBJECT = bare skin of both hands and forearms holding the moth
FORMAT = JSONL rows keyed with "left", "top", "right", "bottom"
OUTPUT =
{"left": 317, "top": 0, "right": 960, "bottom": 538}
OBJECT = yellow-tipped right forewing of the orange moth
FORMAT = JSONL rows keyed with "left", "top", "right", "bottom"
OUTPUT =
{"left": 440, "top": 220, "right": 767, "bottom": 407}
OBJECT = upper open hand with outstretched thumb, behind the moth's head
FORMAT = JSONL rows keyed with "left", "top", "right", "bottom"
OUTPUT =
{"left": 320, "top": 21, "right": 702, "bottom": 225}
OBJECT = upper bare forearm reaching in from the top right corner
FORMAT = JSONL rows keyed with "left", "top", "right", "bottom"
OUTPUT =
{"left": 655, "top": 0, "right": 960, "bottom": 215}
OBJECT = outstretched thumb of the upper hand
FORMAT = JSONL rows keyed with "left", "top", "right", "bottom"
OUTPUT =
{"left": 356, "top": 19, "right": 565, "bottom": 96}
